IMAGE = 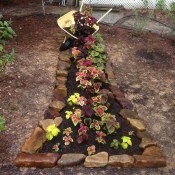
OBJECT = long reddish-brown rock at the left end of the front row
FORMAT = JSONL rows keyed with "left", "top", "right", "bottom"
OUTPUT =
{"left": 13, "top": 153, "right": 60, "bottom": 168}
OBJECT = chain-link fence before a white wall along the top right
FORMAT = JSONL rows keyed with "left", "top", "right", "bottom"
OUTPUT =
{"left": 84, "top": 0, "right": 175, "bottom": 9}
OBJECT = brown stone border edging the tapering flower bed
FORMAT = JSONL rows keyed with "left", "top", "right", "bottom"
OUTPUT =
{"left": 13, "top": 51, "right": 166, "bottom": 168}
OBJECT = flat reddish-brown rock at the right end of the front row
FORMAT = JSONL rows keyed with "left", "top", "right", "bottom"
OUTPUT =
{"left": 133, "top": 155, "right": 166, "bottom": 168}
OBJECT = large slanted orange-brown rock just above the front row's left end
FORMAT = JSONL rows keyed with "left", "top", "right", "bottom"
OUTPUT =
{"left": 21, "top": 127, "right": 46, "bottom": 153}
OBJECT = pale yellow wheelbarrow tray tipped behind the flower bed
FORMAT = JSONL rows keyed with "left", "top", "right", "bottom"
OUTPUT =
{"left": 57, "top": 10, "right": 99, "bottom": 39}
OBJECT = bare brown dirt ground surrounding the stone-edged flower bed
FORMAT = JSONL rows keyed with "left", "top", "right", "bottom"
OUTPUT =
{"left": 0, "top": 5, "right": 175, "bottom": 175}
